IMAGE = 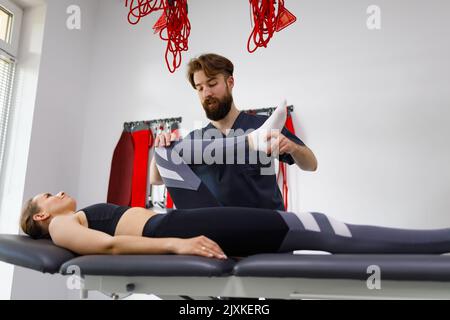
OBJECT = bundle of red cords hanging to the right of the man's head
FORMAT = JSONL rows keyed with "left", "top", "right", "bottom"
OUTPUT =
{"left": 247, "top": 0, "right": 297, "bottom": 53}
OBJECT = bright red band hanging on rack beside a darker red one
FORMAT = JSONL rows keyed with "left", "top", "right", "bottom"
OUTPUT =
{"left": 131, "top": 129, "right": 153, "bottom": 208}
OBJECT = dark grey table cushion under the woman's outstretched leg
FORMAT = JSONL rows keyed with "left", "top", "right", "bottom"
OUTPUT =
{"left": 233, "top": 254, "right": 450, "bottom": 281}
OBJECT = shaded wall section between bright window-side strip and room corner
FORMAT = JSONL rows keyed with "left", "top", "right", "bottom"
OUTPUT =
{"left": 11, "top": 0, "right": 97, "bottom": 299}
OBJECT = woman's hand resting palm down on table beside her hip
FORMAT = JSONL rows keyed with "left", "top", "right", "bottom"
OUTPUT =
{"left": 174, "top": 236, "right": 227, "bottom": 259}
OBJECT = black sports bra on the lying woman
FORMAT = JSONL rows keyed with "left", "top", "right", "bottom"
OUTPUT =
{"left": 79, "top": 203, "right": 130, "bottom": 236}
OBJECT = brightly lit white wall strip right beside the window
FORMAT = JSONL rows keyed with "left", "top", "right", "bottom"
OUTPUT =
{"left": 0, "top": 0, "right": 45, "bottom": 299}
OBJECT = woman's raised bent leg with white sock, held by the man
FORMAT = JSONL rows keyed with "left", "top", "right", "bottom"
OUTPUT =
{"left": 155, "top": 104, "right": 286, "bottom": 209}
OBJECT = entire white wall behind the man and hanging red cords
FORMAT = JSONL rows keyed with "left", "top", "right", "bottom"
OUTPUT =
{"left": 5, "top": 0, "right": 450, "bottom": 298}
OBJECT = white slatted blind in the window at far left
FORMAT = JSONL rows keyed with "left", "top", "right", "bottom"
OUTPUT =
{"left": 0, "top": 55, "right": 15, "bottom": 176}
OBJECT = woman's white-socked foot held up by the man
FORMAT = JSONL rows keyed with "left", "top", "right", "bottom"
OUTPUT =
{"left": 248, "top": 100, "right": 287, "bottom": 153}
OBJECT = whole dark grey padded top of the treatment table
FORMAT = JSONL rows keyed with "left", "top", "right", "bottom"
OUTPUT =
{"left": 0, "top": 235, "right": 450, "bottom": 281}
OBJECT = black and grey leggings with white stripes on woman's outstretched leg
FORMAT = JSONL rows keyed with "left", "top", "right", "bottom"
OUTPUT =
{"left": 143, "top": 207, "right": 450, "bottom": 256}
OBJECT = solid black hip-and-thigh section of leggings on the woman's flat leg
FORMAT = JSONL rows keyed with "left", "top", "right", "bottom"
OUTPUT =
{"left": 148, "top": 207, "right": 289, "bottom": 256}
